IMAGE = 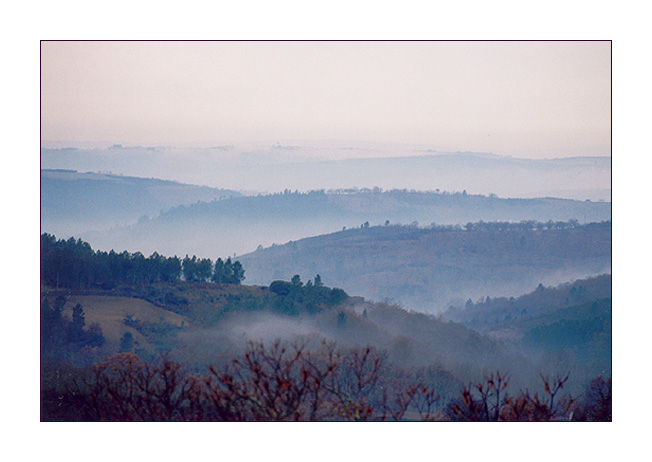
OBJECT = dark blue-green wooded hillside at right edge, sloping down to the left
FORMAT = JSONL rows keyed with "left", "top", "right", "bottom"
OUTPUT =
{"left": 444, "top": 275, "right": 612, "bottom": 386}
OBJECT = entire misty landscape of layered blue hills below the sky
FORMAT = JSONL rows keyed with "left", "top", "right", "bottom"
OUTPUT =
{"left": 40, "top": 160, "right": 612, "bottom": 422}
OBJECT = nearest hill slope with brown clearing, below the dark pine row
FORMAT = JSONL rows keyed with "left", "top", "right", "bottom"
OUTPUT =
{"left": 41, "top": 282, "right": 536, "bottom": 392}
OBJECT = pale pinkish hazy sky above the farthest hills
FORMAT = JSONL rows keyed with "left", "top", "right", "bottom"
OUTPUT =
{"left": 41, "top": 42, "right": 611, "bottom": 161}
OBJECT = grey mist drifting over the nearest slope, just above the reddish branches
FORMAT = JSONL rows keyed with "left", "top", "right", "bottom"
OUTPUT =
{"left": 174, "top": 304, "right": 595, "bottom": 391}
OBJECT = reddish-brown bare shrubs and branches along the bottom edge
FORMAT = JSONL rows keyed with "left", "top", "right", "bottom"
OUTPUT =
{"left": 41, "top": 342, "right": 611, "bottom": 421}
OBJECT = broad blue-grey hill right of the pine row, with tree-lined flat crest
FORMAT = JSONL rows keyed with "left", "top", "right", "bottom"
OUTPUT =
{"left": 238, "top": 221, "right": 611, "bottom": 312}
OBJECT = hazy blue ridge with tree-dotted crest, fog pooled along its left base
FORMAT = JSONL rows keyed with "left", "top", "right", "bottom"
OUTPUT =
{"left": 80, "top": 188, "right": 611, "bottom": 260}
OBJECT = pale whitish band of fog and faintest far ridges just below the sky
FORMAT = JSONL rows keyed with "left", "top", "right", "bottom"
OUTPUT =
{"left": 41, "top": 142, "right": 611, "bottom": 200}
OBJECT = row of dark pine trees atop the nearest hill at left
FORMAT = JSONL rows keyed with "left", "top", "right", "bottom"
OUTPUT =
{"left": 41, "top": 233, "right": 245, "bottom": 290}
